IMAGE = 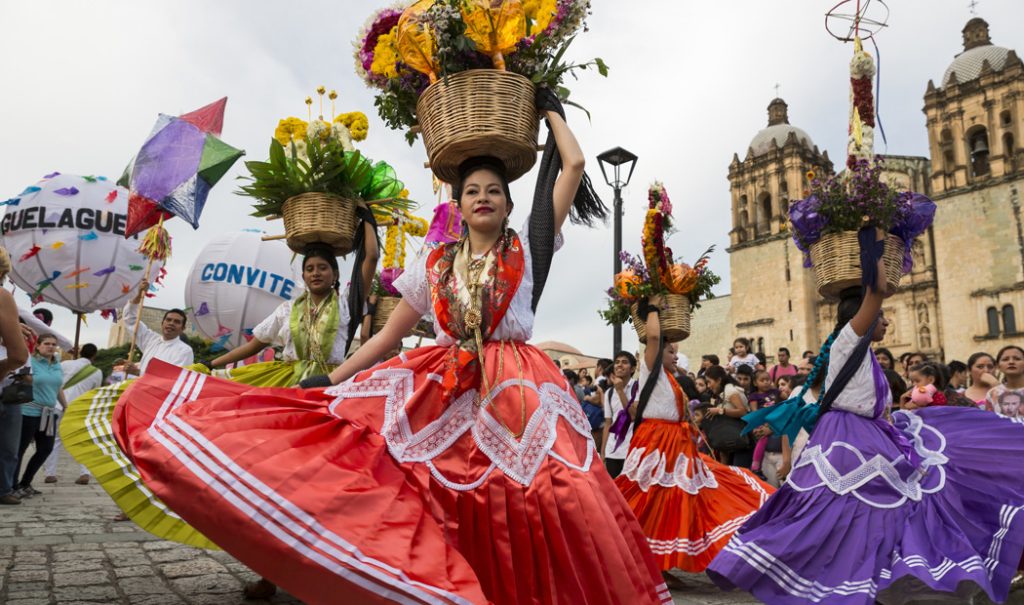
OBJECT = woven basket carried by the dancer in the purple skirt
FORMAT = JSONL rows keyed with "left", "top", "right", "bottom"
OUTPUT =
{"left": 811, "top": 231, "right": 903, "bottom": 300}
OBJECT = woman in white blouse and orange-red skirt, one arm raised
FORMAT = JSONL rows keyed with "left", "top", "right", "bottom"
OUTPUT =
{"left": 615, "top": 297, "right": 773, "bottom": 572}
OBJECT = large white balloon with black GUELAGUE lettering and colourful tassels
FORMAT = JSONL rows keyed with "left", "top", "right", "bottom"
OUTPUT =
{"left": 0, "top": 173, "right": 163, "bottom": 313}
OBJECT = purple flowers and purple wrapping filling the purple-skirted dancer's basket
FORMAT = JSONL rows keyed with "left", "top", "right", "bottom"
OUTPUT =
{"left": 790, "top": 158, "right": 935, "bottom": 273}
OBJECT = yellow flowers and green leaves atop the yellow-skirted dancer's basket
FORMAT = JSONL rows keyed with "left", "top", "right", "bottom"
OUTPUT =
{"left": 239, "top": 86, "right": 414, "bottom": 217}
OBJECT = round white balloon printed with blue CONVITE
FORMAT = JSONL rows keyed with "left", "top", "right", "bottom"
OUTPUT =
{"left": 185, "top": 231, "right": 302, "bottom": 349}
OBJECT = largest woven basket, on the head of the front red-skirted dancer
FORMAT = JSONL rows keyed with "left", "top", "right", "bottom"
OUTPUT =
{"left": 416, "top": 70, "right": 539, "bottom": 183}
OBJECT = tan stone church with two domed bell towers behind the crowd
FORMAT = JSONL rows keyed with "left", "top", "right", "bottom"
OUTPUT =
{"left": 680, "top": 18, "right": 1024, "bottom": 366}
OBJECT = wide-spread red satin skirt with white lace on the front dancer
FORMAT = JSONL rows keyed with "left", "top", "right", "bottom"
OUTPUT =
{"left": 114, "top": 343, "right": 672, "bottom": 604}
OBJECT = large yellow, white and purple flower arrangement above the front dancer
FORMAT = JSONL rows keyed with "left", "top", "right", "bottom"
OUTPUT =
{"left": 354, "top": 0, "right": 607, "bottom": 142}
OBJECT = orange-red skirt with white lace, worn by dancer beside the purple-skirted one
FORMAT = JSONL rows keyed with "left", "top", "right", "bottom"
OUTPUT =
{"left": 615, "top": 419, "right": 774, "bottom": 573}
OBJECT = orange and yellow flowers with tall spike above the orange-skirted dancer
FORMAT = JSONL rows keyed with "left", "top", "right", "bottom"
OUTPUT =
{"left": 599, "top": 182, "right": 722, "bottom": 325}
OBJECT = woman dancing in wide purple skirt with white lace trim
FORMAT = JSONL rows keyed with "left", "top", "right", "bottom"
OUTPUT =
{"left": 708, "top": 228, "right": 1024, "bottom": 605}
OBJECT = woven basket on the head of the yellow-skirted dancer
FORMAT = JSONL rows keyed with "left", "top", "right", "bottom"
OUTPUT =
{"left": 282, "top": 193, "right": 356, "bottom": 256}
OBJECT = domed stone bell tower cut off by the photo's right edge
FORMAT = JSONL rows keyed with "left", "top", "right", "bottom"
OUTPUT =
{"left": 924, "top": 17, "right": 1024, "bottom": 359}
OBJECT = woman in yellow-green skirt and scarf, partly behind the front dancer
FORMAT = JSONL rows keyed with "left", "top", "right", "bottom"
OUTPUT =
{"left": 60, "top": 233, "right": 378, "bottom": 549}
